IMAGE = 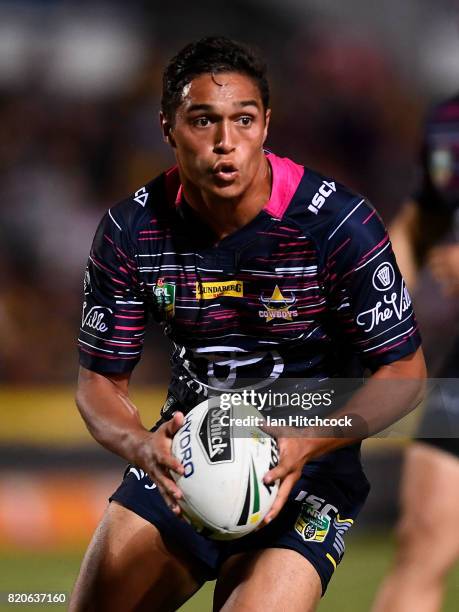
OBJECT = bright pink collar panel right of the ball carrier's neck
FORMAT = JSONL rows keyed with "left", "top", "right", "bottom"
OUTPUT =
{"left": 264, "top": 153, "right": 304, "bottom": 219}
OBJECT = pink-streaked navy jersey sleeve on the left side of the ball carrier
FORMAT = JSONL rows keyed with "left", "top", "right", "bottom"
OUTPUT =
{"left": 78, "top": 211, "right": 147, "bottom": 373}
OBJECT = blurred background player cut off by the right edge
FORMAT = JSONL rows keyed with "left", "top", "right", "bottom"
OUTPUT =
{"left": 373, "top": 96, "right": 459, "bottom": 612}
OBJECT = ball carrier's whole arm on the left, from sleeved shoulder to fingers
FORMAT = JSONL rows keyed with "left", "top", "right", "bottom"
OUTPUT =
{"left": 76, "top": 201, "right": 183, "bottom": 513}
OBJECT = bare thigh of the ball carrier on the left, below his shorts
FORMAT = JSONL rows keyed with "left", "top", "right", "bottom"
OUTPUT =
{"left": 69, "top": 502, "right": 207, "bottom": 612}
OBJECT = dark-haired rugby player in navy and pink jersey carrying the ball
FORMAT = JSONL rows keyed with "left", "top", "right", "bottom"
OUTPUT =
{"left": 70, "top": 37, "right": 425, "bottom": 612}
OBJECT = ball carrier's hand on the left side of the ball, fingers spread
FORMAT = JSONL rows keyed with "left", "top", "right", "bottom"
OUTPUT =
{"left": 135, "top": 412, "right": 185, "bottom": 516}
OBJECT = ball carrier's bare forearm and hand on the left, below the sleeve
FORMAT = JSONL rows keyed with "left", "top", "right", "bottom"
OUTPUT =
{"left": 76, "top": 367, "right": 184, "bottom": 514}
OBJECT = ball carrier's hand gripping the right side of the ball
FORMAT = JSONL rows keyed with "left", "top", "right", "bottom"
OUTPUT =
{"left": 262, "top": 437, "right": 312, "bottom": 525}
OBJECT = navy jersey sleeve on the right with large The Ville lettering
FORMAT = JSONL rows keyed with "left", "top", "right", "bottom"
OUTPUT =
{"left": 326, "top": 200, "right": 421, "bottom": 370}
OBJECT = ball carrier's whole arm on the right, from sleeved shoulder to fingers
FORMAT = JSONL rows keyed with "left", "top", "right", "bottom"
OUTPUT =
{"left": 265, "top": 200, "right": 426, "bottom": 522}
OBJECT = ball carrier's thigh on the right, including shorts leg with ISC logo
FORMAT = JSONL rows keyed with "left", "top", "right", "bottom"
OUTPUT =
{"left": 214, "top": 470, "right": 368, "bottom": 611}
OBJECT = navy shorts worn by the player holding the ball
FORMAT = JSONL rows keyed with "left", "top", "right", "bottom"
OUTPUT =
{"left": 110, "top": 466, "right": 370, "bottom": 593}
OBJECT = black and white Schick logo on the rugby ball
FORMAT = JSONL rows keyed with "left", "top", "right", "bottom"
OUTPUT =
{"left": 198, "top": 406, "right": 233, "bottom": 463}
